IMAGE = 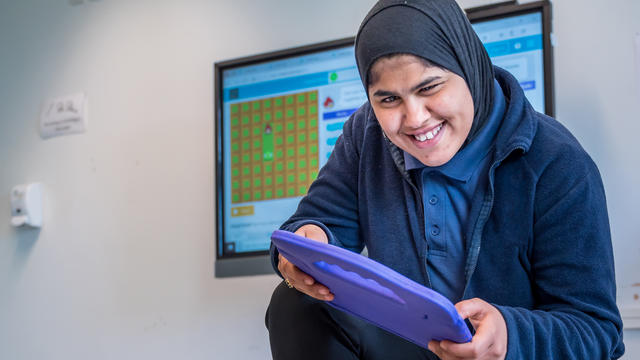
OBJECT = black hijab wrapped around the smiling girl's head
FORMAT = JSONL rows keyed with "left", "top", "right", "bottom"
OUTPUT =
{"left": 355, "top": 0, "right": 494, "bottom": 142}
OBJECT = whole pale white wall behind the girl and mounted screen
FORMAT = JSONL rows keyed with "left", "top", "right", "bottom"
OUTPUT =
{"left": 0, "top": 0, "right": 640, "bottom": 359}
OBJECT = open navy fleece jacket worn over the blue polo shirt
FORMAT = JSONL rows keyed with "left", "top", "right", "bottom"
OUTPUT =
{"left": 272, "top": 67, "right": 624, "bottom": 359}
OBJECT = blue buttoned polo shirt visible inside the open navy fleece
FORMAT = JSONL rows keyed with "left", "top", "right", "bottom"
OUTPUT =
{"left": 404, "top": 81, "right": 506, "bottom": 303}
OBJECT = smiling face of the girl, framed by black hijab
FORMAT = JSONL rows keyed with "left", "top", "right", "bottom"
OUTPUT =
{"left": 367, "top": 55, "right": 474, "bottom": 166}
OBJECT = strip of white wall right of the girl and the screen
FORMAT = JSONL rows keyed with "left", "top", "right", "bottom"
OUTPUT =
{"left": 553, "top": 0, "right": 640, "bottom": 359}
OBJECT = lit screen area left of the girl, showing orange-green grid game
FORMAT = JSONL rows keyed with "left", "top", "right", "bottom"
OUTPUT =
{"left": 220, "top": 46, "right": 366, "bottom": 254}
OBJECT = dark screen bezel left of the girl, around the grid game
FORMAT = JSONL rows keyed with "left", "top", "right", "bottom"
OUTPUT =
{"left": 213, "top": 37, "right": 355, "bottom": 277}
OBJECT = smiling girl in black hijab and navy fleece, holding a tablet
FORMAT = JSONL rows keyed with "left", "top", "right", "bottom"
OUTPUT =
{"left": 266, "top": 0, "right": 624, "bottom": 360}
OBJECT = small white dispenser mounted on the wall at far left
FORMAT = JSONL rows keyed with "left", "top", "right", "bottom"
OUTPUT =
{"left": 10, "top": 183, "right": 42, "bottom": 227}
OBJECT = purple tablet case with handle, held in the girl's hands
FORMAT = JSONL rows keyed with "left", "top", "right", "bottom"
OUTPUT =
{"left": 271, "top": 230, "right": 471, "bottom": 348}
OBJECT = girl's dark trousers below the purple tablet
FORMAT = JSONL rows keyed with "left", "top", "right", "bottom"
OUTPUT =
{"left": 265, "top": 282, "right": 438, "bottom": 360}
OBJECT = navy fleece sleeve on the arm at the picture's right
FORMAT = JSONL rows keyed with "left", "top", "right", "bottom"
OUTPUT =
{"left": 496, "top": 146, "right": 624, "bottom": 359}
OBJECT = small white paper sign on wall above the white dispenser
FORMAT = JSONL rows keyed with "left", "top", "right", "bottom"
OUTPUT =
{"left": 40, "top": 93, "right": 87, "bottom": 139}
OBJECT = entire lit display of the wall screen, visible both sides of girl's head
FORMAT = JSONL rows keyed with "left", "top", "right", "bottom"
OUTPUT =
{"left": 216, "top": 3, "right": 549, "bottom": 276}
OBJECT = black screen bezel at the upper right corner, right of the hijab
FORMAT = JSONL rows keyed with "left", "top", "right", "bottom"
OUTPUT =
{"left": 466, "top": 0, "right": 555, "bottom": 117}
